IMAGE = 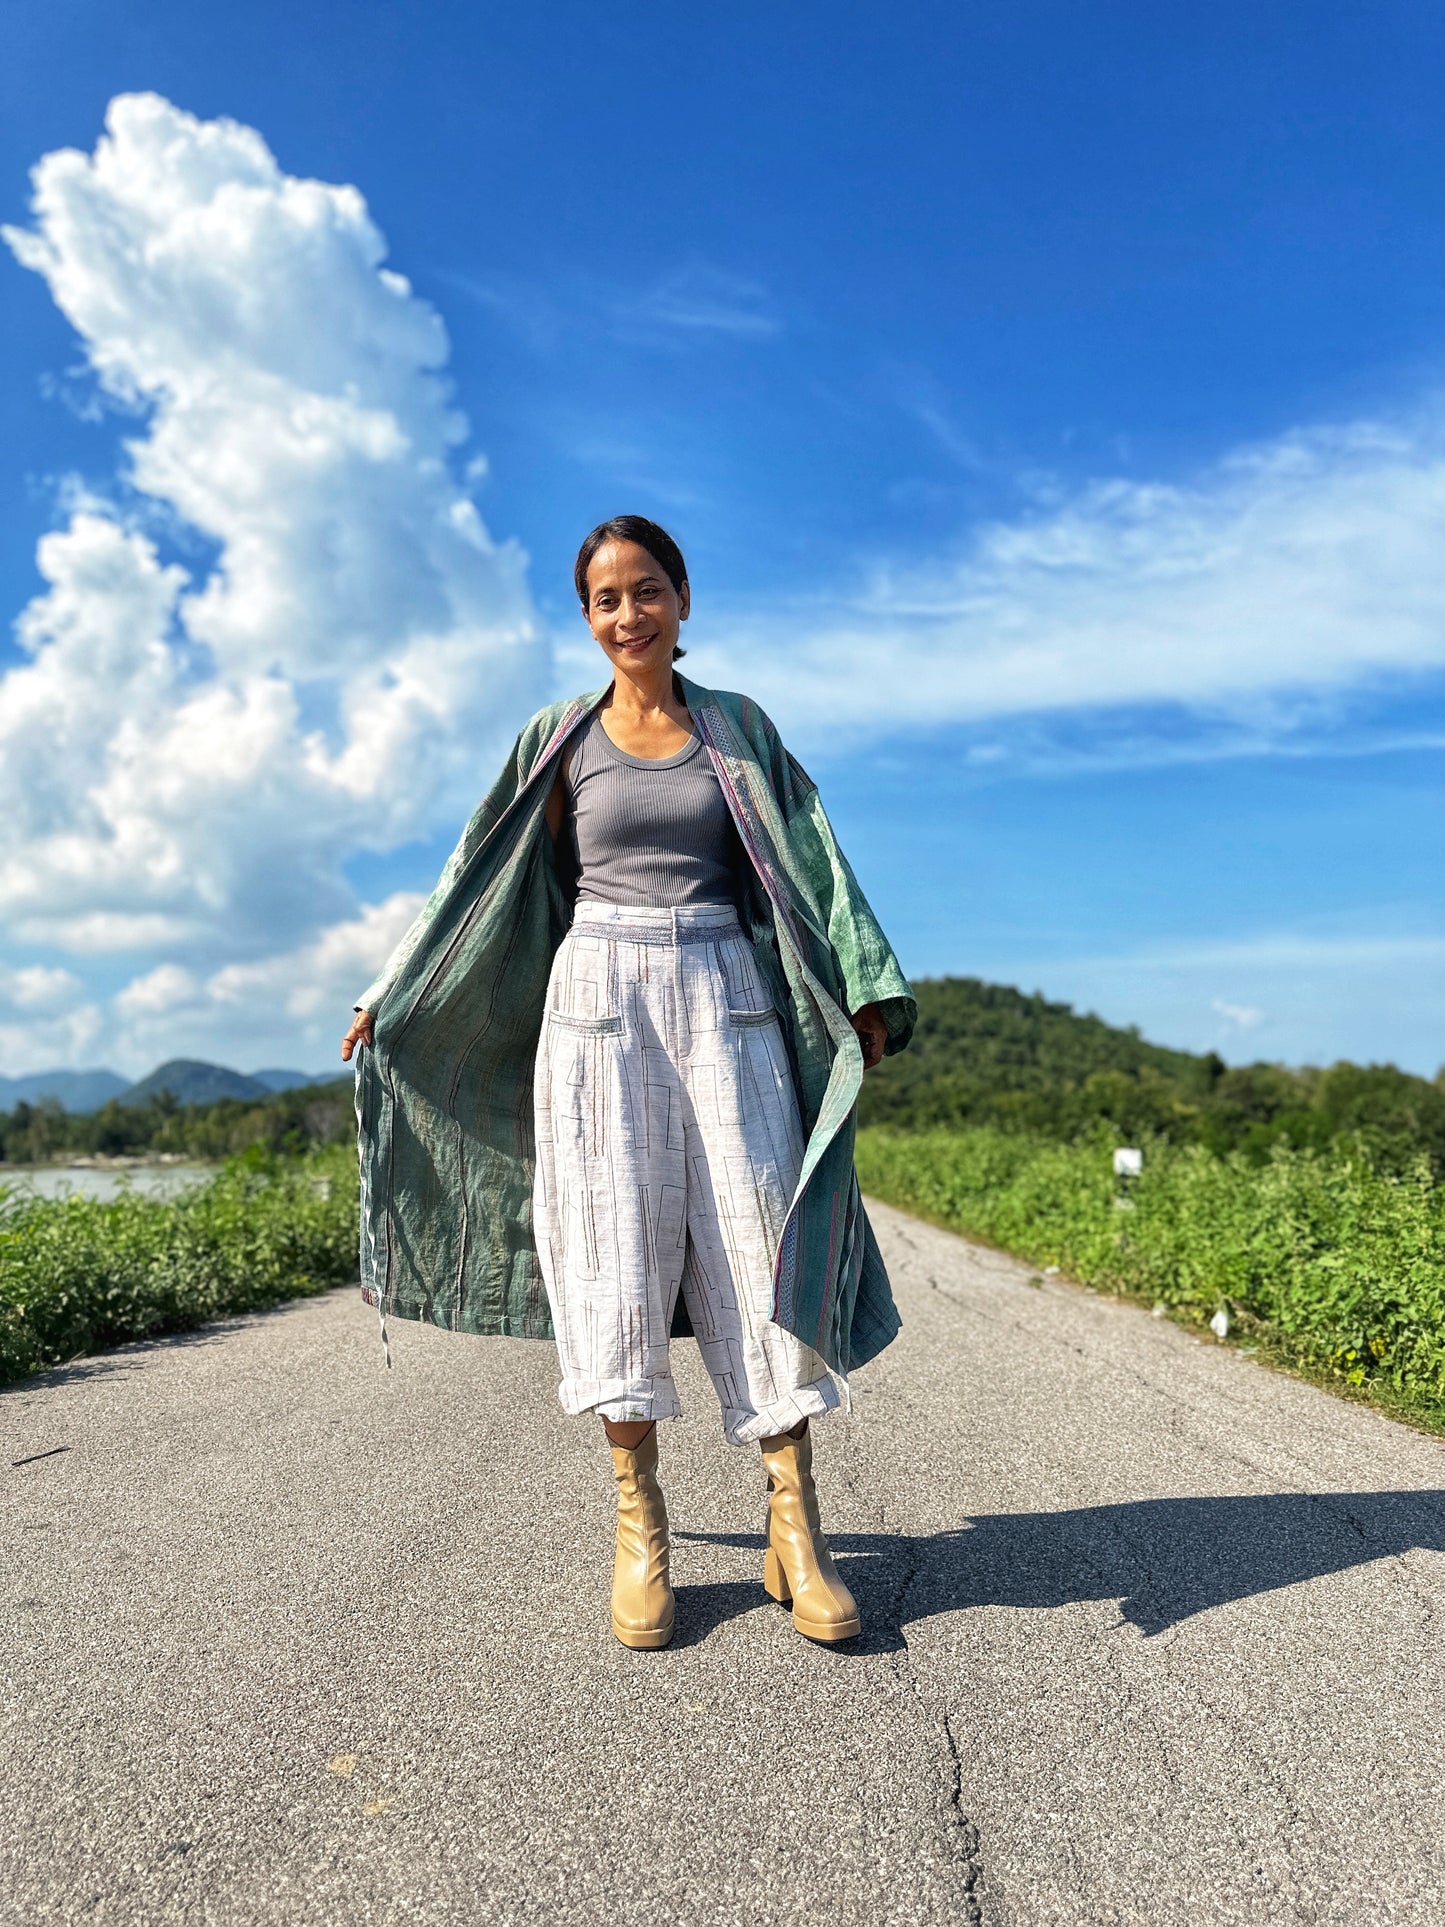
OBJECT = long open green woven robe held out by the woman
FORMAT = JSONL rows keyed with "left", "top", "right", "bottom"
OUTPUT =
{"left": 356, "top": 676, "right": 917, "bottom": 1372}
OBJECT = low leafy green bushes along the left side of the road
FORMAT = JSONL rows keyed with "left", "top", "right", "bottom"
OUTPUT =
{"left": 0, "top": 1145, "right": 358, "bottom": 1382}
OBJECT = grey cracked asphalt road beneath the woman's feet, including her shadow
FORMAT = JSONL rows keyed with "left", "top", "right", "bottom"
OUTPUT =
{"left": 0, "top": 1206, "right": 1445, "bottom": 1927}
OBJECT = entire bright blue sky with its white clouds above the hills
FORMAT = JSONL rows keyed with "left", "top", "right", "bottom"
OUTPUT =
{"left": 0, "top": 0, "right": 1445, "bottom": 1073}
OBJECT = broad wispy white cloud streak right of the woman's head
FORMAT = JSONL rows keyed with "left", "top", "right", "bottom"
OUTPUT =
{"left": 697, "top": 407, "right": 1445, "bottom": 742}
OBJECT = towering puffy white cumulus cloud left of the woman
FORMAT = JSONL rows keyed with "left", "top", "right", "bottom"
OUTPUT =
{"left": 0, "top": 94, "right": 547, "bottom": 1056}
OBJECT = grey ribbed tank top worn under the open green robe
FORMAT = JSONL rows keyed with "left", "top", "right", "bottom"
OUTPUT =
{"left": 563, "top": 713, "right": 742, "bottom": 910}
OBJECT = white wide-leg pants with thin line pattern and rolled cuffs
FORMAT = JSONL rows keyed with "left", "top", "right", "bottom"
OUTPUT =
{"left": 534, "top": 902, "right": 842, "bottom": 1445}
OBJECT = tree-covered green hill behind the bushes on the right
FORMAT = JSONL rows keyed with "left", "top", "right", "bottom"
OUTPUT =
{"left": 859, "top": 977, "right": 1445, "bottom": 1168}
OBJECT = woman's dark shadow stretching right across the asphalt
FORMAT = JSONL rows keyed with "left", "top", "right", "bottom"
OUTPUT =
{"left": 672, "top": 1491, "right": 1445, "bottom": 1651}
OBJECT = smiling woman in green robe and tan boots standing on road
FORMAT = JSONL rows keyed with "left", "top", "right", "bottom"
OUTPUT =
{"left": 341, "top": 516, "right": 917, "bottom": 1648}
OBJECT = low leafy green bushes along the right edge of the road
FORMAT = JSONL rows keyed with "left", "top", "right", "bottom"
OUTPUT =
{"left": 857, "top": 1129, "right": 1445, "bottom": 1428}
